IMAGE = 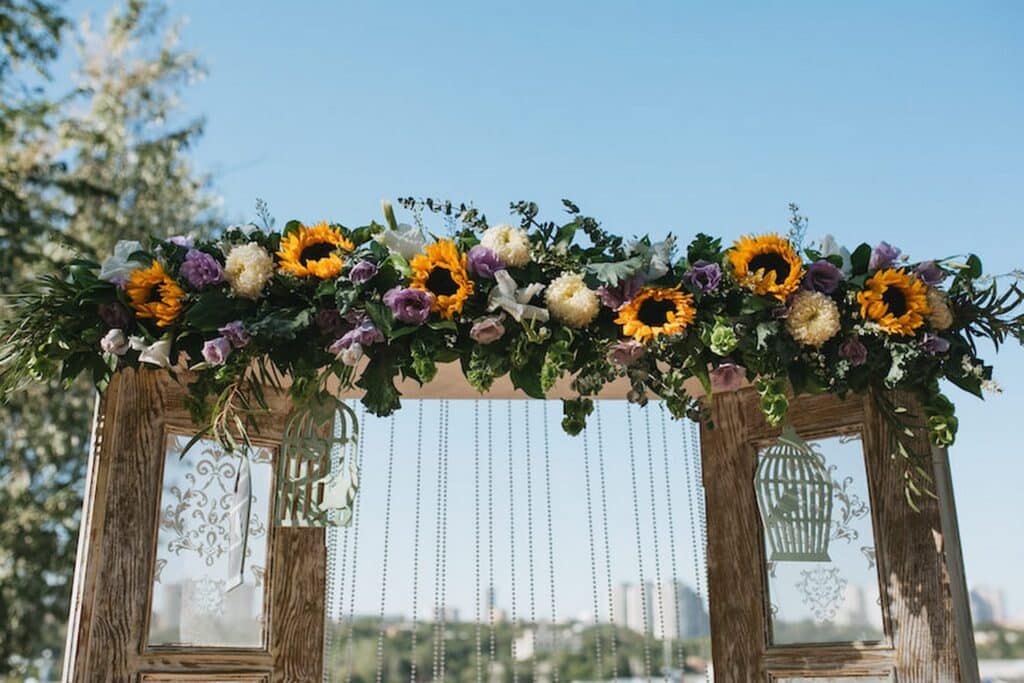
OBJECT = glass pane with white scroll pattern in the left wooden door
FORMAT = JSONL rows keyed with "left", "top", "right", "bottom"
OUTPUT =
{"left": 148, "top": 434, "right": 273, "bottom": 648}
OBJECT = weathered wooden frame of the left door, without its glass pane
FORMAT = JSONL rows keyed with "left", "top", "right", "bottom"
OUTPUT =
{"left": 62, "top": 369, "right": 327, "bottom": 683}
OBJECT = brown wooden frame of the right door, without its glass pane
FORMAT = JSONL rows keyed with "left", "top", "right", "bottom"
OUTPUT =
{"left": 701, "top": 388, "right": 977, "bottom": 683}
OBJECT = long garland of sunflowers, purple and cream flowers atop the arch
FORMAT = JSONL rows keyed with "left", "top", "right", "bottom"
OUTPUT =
{"left": 0, "top": 199, "right": 1024, "bottom": 501}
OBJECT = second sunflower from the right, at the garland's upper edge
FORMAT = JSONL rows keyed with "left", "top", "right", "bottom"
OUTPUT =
{"left": 728, "top": 233, "right": 804, "bottom": 301}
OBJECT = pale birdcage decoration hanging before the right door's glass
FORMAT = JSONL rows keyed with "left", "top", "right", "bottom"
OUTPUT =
{"left": 754, "top": 425, "right": 833, "bottom": 562}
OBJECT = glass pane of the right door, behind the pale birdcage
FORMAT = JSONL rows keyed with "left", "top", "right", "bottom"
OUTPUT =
{"left": 757, "top": 435, "right": 885, "bottom": 643}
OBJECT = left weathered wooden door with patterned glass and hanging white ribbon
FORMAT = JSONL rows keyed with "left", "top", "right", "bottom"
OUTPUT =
{"left": 63, "top": 370, "right": 326, "bottom": 683}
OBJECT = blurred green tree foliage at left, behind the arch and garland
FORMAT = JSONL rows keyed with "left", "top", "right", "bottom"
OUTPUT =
{"left": 0, "top": 0, "right": 218, "bottom": 679}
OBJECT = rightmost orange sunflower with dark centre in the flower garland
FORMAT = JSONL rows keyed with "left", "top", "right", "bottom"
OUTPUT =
{"left": 857, "top": 268, "right": 931, "bottom": 336}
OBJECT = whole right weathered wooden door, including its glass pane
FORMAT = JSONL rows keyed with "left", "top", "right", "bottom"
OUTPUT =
{"left": 701, "top": 389, "right": 978, "bottom": 683}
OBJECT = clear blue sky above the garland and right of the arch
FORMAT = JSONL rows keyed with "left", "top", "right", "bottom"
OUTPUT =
{"left": 69, "top": 1, "right": 1024, "bottom": 616}
